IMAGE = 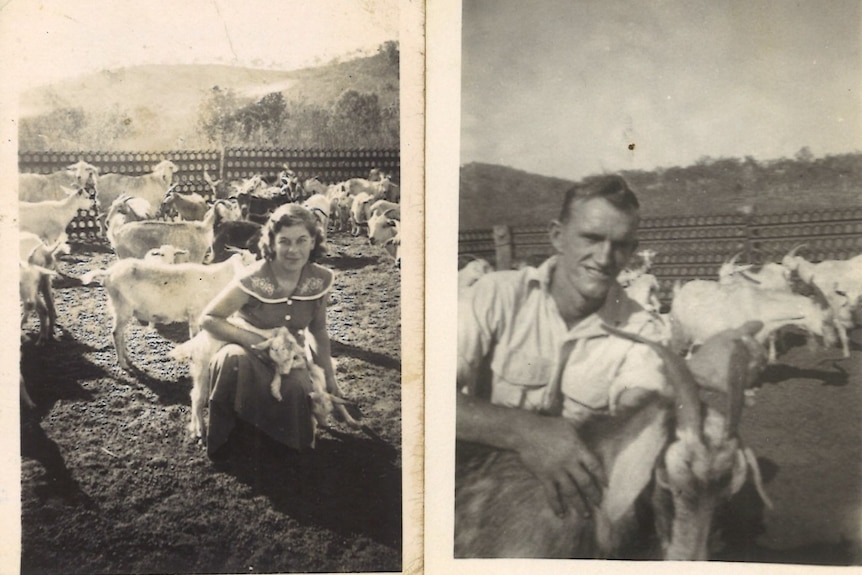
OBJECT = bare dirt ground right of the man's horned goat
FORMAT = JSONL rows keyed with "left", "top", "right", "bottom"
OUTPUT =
{"left": 717, "top": 329, "right": 862, "bottom": 565}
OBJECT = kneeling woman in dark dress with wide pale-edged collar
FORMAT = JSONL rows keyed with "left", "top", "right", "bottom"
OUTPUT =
{"left": 201, "top": 204, "right": 340, "bottom": 459}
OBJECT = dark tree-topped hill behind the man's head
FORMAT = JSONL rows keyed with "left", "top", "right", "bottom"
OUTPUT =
{"left": 459, "top": 153, "right": 862, "bottom": 231}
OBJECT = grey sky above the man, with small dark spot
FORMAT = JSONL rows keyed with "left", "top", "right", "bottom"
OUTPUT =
{"left": 461, "top": 0, "right": 862, "bottom": 179}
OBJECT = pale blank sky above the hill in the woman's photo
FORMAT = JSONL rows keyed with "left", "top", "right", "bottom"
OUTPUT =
{"left": 0, "top": 0, "right": 399, "bottom": 89}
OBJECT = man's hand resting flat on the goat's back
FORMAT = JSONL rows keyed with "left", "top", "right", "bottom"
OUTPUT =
{"left": 517, "top": 414, "right": 607, "bottom": 517}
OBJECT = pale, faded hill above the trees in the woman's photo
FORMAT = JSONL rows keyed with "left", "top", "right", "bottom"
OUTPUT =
{"left": 20, "top": 52, "right": 399, "bottom": 150}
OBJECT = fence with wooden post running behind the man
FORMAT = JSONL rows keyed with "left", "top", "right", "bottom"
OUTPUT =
{"left": 458, "top": 208, "right": 862, "bottom": 301}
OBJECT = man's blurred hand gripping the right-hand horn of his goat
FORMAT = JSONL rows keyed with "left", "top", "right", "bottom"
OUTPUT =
{"left": 688, "top": 321, "right": 766, "bottom": 392}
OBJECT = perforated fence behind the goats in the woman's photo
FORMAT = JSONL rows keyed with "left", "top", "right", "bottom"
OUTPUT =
{"left": 18, "top": 148, "right": 401, "bottom": 242}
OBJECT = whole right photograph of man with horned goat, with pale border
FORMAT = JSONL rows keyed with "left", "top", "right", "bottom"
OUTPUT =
{"left": 426, "top": 0, "right": 862, "bottom": 573}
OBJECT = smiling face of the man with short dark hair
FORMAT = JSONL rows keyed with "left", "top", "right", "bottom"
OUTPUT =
{"left": 550, "top": 198, "right": 638, "bottom": 302}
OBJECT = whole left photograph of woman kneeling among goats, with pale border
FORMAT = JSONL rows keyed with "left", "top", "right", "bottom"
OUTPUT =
{"left": 0, "top": 0, "right": 424, "bottom": 575}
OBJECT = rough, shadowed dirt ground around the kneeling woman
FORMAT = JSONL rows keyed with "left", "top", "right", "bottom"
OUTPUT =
{"left": 21, "top": 235, "right": 402, "bottom": 575}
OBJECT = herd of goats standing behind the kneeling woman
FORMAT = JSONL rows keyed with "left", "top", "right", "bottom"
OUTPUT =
{"left": 19, "top": 160, "right": 400, "bottom": 436}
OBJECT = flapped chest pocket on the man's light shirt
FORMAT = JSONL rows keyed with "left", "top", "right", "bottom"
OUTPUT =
{"left": 491, "top": 350, "right": 553, "bottom": 410}
